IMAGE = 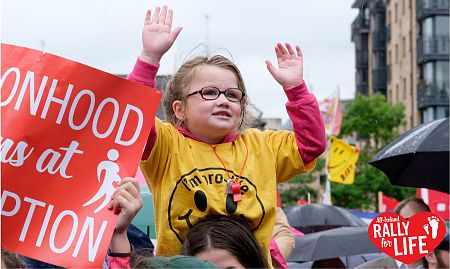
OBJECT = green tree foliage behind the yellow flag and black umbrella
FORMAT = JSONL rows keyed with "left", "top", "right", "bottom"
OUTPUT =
{"left": 331, "top": 94, "right": 415, "bottom": 209}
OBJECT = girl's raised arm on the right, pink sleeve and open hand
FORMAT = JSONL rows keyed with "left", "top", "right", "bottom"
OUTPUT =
{"left": 266, "top": 43, "right": 326, "bottom": 165}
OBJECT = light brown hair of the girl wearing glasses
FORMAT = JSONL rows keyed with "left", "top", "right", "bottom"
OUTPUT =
{"left": 164, "top": 55, "right": 249, "bottom": 131}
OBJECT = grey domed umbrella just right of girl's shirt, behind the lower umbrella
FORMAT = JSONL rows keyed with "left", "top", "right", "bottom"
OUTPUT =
{"left": 284, "top": 204, "right": 367, "bottom": 233}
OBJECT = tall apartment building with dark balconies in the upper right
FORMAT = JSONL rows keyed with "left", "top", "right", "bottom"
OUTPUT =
{"left": 352, "top": 0, "right": 450, "bottom": 132}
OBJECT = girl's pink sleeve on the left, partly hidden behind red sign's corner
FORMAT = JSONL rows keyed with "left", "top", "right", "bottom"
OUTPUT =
{"left": 128, "top": 58, "right": 159, "bottom": 160}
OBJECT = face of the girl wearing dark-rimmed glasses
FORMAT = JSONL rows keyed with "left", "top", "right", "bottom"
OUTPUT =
{"left": 173, "top": 65, "right": 241, "bottom": 144}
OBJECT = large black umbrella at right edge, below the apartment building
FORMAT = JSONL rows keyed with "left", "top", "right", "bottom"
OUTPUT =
{"left": 369, "top": 118, "right": 450, "bottom": 193}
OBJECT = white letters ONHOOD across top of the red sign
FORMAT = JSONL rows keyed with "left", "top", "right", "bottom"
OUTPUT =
{"left": 0, "top": 67, "right": 144, "bottom": 146}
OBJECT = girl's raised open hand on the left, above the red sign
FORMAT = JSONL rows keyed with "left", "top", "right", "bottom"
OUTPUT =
{"left": 139, "top": 6, "right": 183, "bottom": 65}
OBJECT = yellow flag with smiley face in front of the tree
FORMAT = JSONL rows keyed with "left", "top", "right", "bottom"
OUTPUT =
{"left": 328, "top": 137, "right": 359, "bottom": 184}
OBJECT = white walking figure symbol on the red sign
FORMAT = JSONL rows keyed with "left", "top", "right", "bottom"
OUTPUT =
{"left": 83, "top": 149, "right": 120, "bottom": 214}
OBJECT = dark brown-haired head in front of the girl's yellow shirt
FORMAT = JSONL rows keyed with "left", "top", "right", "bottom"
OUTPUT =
{"left": 181, "top": 215, "right": 269, "bottom": 268}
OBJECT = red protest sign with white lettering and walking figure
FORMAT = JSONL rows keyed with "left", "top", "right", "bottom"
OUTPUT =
{"left": 0, "top": 44, "right": 161, "bottom": 268}
